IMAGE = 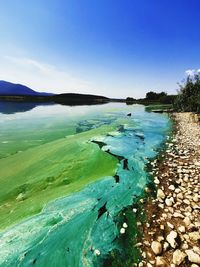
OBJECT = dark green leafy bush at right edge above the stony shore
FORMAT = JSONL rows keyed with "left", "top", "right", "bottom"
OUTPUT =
{"left": 174, "top": 74, "right": 200, "bottom": 113}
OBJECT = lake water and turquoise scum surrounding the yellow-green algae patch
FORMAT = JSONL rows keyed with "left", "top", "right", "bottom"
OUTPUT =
{"left": 0, "top": 104, "right": 170, "bottom": 267}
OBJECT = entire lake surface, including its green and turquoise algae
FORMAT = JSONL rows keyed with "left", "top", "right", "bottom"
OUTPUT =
{"left": 0, "top": 103, "right": 170, "bottom": 266}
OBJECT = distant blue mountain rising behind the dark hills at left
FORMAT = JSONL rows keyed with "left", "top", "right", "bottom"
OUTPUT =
{"left": 0, "top": 81, "right": 53, "bottom": 96}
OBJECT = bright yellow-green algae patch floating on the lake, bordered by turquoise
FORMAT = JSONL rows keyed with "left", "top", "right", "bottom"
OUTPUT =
{"left": 0, "top": 125, "right": 118, "bottom": 228}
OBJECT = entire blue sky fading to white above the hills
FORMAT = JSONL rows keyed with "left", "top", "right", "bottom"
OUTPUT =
{"left": 0, "top": 0, "right": 200, "bottom": 98}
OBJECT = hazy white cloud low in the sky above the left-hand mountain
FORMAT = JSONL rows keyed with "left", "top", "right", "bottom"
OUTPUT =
{"left": 0, "top": 56, "right": 94, "bottom": 93}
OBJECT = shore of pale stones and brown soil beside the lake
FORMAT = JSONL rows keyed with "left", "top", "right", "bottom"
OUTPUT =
{"left": 138, "top": 113, "right": 200, "bottom": 267}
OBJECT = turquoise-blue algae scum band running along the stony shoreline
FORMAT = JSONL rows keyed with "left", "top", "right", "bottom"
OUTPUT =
{"left": 0, "top": 105, "right": 170, "bottom": 266}
